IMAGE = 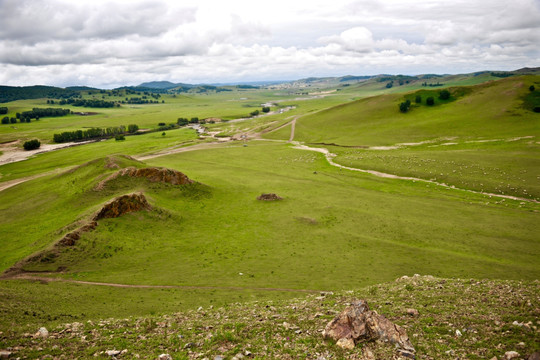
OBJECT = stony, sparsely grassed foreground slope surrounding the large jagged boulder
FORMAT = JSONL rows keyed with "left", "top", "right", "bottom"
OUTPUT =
{"left": 0, "top": 275, "right": 540, "bottom": 360}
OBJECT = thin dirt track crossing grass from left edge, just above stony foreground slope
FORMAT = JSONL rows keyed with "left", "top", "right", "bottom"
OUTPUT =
{"left": 9, "top": 274, "right": 324, "bottom": 293}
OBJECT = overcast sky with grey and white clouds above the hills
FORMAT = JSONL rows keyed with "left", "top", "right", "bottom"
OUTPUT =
{"left": 0, "top": 0, "right": 540, "bottom": 88}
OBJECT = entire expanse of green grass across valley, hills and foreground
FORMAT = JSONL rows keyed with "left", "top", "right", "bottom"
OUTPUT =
{"left": 0, "top": 77, "right": 540, "bottom": 358}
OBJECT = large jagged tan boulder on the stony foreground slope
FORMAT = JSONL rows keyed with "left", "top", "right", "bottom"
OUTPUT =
{"left": 323, "top": 300, "right": 415, "bottom": 358}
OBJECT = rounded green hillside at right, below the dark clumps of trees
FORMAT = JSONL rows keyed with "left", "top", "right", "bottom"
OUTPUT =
{"left": 268, "top": 76, "right": 540, "bottom": 146}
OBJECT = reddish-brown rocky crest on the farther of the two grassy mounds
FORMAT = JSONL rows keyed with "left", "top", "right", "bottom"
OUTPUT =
{"left": 95, "top": 167, "right": 193, "bottom": 190}
